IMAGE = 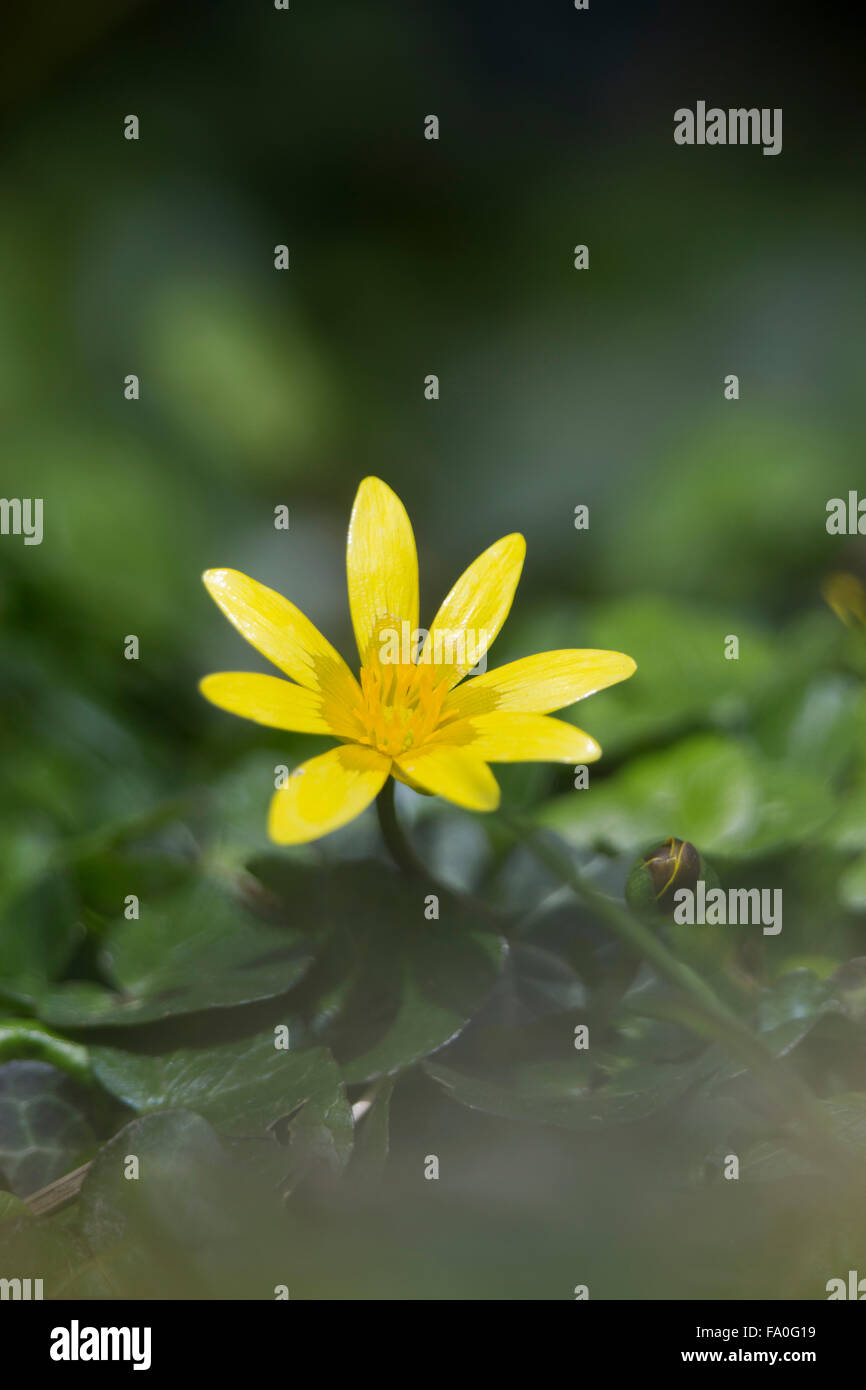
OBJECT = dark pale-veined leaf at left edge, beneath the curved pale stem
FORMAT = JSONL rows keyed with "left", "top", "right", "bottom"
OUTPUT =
{"left": 0, "top": 1062, "right": 96, "bottom": 1197}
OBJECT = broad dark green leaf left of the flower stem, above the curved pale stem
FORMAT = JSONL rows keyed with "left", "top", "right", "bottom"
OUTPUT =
{"left": 38, "top": 881, "right": 310, "bottom": 1027}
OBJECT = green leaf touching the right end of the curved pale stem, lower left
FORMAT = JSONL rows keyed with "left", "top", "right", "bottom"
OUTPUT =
{"left": 90, "top": 1033, "right": 352, "bottom": 1169}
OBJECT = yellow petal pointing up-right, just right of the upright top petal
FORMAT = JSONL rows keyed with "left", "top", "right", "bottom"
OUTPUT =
{"left": 418, "top": 532, "right": 527, "bottom": 685}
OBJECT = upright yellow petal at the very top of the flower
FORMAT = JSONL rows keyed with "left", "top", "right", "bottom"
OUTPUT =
{"left": 346, "top": 478, "right": 418, "bottom": 664}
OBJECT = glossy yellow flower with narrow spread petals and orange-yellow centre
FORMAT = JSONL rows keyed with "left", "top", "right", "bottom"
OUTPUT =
{"left": 200, "top": 478, "right": 635, "bottom": 845}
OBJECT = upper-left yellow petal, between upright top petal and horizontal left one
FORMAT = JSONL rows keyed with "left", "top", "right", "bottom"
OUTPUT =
{"left": 203, "top": 570, "right": 361, "bottom": 717}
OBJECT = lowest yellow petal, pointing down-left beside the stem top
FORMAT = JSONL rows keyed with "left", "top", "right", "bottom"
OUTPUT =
{"left": 268, "top": 744, "right": 391, "bottom": 845}
